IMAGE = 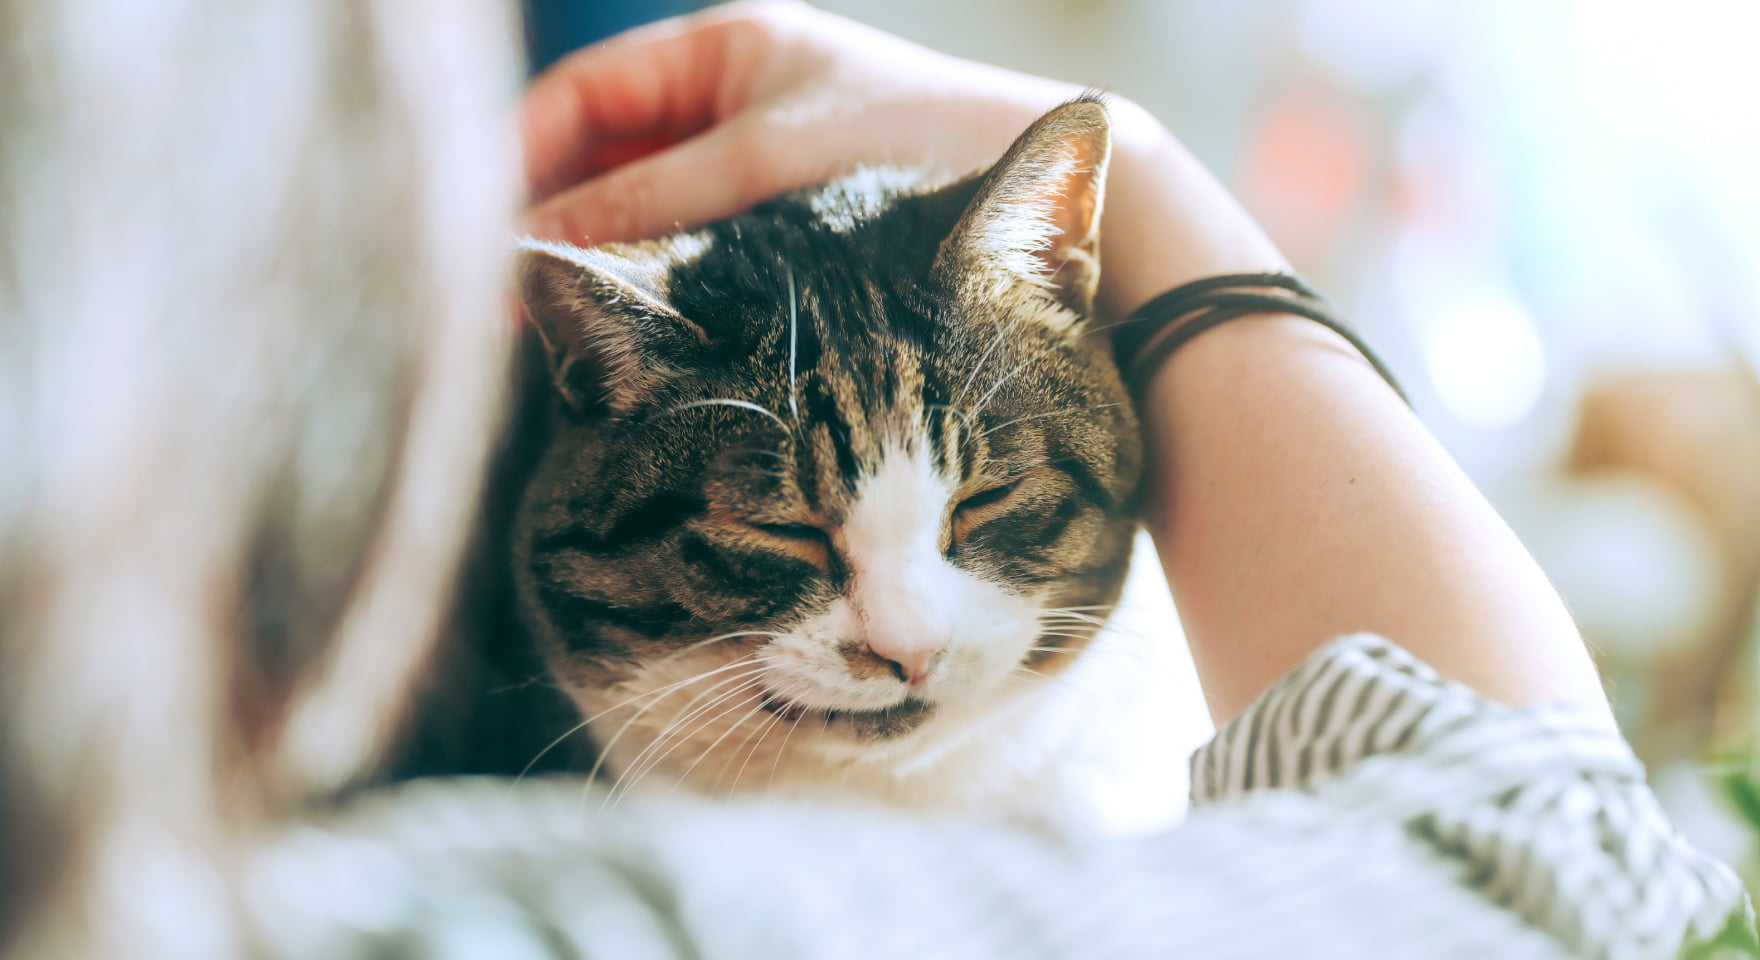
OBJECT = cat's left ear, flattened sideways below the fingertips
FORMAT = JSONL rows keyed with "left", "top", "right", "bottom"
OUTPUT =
{"left": 517, "top": 240, "right": 708, "bottom": 414}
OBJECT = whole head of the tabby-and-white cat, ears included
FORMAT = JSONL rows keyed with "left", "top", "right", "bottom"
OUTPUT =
{"left": 516, "top": 102, "right": 1140, "bottom": 789}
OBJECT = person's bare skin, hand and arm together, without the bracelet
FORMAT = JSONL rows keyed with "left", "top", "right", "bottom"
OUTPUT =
{"left": 523, "top": 2, "right": 1609, "bottom": 722}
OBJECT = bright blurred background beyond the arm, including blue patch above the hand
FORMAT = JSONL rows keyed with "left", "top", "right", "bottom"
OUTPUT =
{"left": 542, "top": 0, "right": 1760, "bottom": 859}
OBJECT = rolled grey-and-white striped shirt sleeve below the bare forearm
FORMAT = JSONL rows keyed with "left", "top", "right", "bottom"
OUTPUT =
{"left": 1192, "top": 636, "right": 1753, "bottom": 958}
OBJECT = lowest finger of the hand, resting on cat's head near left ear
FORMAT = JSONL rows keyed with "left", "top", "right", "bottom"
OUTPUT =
{"left": 526, "top": 123, "right": 776, "bottom": 245}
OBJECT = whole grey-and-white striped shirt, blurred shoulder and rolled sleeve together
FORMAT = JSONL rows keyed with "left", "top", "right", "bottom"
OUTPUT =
{"left": 251, "top": 638, "right": 1760, "bottom": 960}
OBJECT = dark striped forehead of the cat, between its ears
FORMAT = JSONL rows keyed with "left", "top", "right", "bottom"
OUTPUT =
{"left": 598, "top": 167, "right": 1093, "bottom": 414}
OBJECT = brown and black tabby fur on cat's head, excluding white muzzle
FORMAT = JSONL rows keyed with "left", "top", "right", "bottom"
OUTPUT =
{"left": 396, "top": 99, "right": 1142, "bottom": 785}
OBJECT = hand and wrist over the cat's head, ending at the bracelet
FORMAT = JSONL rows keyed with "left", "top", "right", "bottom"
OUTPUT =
{"left": 521, "top": 0, "right": 1283, "bottom": 314}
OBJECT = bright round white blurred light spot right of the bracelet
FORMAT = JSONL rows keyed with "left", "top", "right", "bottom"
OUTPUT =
{"left": 1424, "top": 301, "right": 1545, "bottom": 422}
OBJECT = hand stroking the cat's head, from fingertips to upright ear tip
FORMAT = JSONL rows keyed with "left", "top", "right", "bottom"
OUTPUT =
{"left": 523, "top": 0, "right": 1079, "bottom": 243}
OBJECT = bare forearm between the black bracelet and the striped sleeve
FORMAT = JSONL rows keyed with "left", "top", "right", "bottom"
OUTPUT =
{"left": 1146, "top": 310, "right": 1607, "bottom": 719}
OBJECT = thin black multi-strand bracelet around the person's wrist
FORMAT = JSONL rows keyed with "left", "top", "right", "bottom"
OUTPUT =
{"left": 1112, "top": 273, "right": 1412, "bottom": 405}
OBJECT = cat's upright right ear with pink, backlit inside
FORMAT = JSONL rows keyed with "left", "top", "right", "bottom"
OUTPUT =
{"left": 935, "top": 97, "right": 1111, "bottom": 315}
